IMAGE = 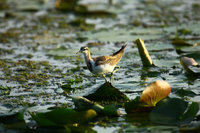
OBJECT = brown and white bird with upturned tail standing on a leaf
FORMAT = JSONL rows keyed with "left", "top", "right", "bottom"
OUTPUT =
{"left": 77, "top": 44, "right": 127, "bottom": 82}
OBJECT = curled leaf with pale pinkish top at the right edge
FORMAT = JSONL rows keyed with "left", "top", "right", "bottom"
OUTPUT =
{"left": 180, "top": 57, "right": 200, "bottom": 75}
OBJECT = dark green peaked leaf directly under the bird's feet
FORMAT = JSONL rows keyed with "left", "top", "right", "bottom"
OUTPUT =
{"left": 84, "top": 82, "right": 129, "bottom": 103}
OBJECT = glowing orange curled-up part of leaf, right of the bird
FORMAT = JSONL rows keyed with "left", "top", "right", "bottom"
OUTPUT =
{"left": 139, "top": 80, "right": 171, "bottom": 106}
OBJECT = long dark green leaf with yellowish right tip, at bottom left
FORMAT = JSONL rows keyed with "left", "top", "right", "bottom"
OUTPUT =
{"left": 31, "top": 108, "right": 97, "bottom": 126}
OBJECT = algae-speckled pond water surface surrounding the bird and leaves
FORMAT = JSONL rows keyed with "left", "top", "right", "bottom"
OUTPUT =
{"left": 0, "top": 0, "right": 200, "bottom": 132}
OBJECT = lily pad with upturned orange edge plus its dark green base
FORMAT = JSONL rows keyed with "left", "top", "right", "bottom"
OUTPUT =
{"left": 125, "top": 80, "right": 171, "bottom": 114}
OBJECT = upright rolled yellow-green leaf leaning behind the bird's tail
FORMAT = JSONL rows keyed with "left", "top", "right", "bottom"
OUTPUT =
{"left": 135, "top": 39, "right": 153, "bottom": 67}
